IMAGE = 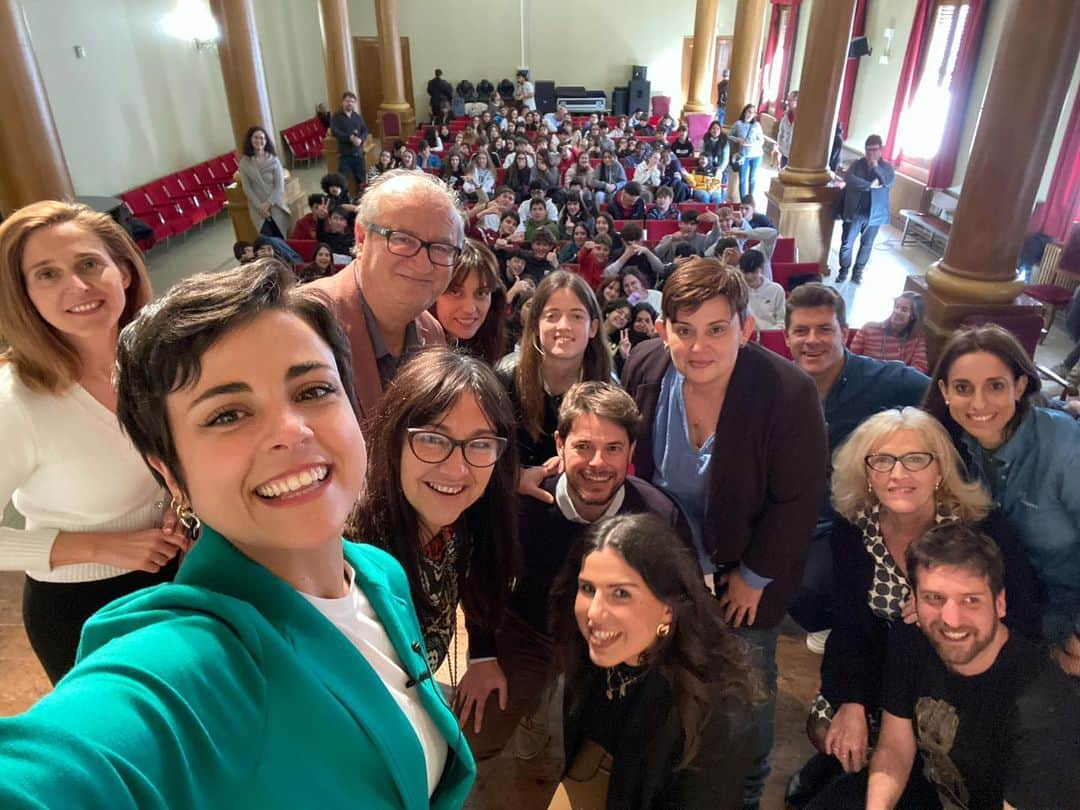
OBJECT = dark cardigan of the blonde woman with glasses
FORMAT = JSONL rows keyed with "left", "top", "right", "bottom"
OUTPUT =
{"left": 821, "top": 510, "right": 1041, "bottom": 711}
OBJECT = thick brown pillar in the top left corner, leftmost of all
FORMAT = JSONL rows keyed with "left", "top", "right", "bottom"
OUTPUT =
{"left": 0, "top": 0, "right": 73, "bottom": 215}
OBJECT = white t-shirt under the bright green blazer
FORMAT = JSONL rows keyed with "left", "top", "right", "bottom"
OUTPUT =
{"left": 300, "top": 564, "right": 449, "bottom": 797}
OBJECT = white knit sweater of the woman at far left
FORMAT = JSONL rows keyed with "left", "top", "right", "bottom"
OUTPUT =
{"left": 0, "top": 363, "right": 167, "bottom": 582}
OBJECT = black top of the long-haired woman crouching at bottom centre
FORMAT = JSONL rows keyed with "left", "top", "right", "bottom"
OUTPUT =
{"left": 563, "top": 664, "right": 754, "bottom": 810}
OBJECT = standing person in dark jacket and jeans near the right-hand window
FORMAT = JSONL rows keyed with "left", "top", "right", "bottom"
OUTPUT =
{"left": 836, "top": 135, "right": 896, "bottom": 284}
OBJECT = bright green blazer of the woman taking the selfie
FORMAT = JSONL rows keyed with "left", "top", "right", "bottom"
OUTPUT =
{"left": 0, "top": 528, "right": 476, "bottom": 810}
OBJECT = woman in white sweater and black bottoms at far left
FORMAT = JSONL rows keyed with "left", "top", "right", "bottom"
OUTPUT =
{"left": 0, "top": 201, "right": 179, "bottom": 684}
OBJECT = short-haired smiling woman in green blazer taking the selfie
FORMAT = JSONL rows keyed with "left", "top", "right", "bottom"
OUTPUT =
{"left": 0, "top": 259, "right": 475, "bottom": 810}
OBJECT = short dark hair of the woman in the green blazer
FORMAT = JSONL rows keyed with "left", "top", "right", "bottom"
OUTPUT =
{"left": 117, "top": 258, "right": 359, "bottom": 498}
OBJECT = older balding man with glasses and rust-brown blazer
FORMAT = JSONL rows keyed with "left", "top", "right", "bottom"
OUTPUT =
{"left": 310, "top": 171, "right": 464, "bottom": 428}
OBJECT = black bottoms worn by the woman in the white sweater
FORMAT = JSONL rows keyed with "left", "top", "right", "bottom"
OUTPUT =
{"left": 23, "top": 557, "right": 179, "bottom": 684}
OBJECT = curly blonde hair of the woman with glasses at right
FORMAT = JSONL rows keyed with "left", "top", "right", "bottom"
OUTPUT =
{"left": 833, "top": 407, "right": 990, "bottom": 523}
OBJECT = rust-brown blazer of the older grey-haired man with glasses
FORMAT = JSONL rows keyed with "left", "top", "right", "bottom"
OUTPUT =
{"left": 307, "top": 261, "right": 446, "bottom": 434}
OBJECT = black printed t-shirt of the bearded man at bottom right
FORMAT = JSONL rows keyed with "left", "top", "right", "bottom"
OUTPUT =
{"left": 885, "top": 625, "right": 1080, "bottom": 810}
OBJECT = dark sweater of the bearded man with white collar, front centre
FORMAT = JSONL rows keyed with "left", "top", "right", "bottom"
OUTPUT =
{"left": 469, "top": 475, "right": 691, "bottom": 658}
